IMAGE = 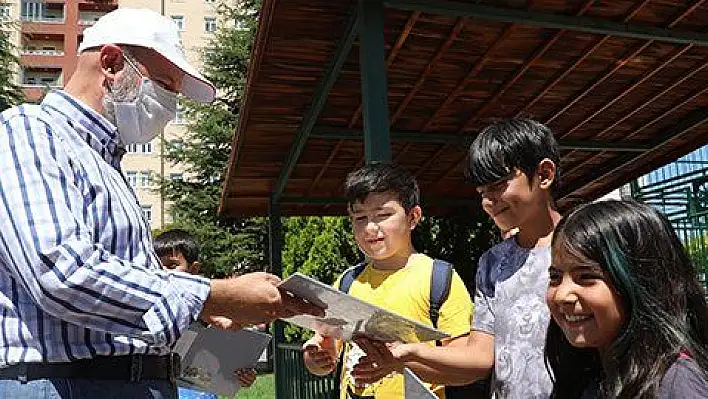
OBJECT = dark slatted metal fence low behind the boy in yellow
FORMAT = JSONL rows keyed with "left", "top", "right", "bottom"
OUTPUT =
{"left": 275, "top": 344, "right": 339, "bottom": 399}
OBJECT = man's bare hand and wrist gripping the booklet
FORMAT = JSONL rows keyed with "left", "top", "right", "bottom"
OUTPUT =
{"left": 200, "top": 272, "right": 324, "bottom": 328}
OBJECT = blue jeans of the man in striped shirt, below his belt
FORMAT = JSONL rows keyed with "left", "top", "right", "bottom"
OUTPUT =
{"left": 0, "top": 378, "right": 177, "bottom": 399}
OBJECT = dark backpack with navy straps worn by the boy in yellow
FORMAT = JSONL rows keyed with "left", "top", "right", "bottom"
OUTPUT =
{"left": 339, "top": 259, "right": 490, "bottom": 399}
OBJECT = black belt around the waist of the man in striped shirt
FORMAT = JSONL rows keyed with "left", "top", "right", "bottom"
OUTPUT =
{"left": 0, "top": 353, "right": 181, "bottom": 383}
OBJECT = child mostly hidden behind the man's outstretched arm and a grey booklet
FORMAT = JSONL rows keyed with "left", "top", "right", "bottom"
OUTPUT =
{"left": 153, "top": 229, "right": 256, "bottom": 399}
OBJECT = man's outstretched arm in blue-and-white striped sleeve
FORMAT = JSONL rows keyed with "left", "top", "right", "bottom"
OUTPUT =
{"left": 0, "top": 116, "right": 318, "bottom": 345}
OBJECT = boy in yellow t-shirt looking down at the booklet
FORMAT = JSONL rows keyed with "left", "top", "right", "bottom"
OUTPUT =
{"left": 303, "top": 164, "right": 473, "bottom": 399}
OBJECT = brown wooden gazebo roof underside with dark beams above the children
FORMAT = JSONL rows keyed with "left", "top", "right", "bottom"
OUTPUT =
{"left": 221, "top": 0, "right": 708, "bottom": 216}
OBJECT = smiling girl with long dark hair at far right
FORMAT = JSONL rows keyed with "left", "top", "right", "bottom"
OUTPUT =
{"left": 546, "top": 201, "right": 708, "bottom": 399}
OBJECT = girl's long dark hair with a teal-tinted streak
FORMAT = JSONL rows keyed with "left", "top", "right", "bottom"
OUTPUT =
{"left": 545, "top": 201, "right": 708, "bottom": 398}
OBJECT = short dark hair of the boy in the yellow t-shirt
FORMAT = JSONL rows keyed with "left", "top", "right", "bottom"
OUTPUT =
{"left": 344, "top": 163, "right": 420, "bottom": 212}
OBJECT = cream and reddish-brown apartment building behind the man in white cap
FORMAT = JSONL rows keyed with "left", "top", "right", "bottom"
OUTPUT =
{"left": 0, "top": 0, "right": 220, "bottom": 228}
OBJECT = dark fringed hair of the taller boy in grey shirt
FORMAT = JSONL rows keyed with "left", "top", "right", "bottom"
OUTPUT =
{"left": 465, "top": 118, "right": 560, "bottom": 194}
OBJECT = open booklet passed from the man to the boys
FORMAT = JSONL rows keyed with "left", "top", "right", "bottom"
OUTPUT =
{"left": 278, "top": 273, "right": 449, "bottom": 343}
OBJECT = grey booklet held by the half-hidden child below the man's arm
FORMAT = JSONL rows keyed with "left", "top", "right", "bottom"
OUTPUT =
{"left": 174, "top": 325, "right": 271, "bottom": 397}
